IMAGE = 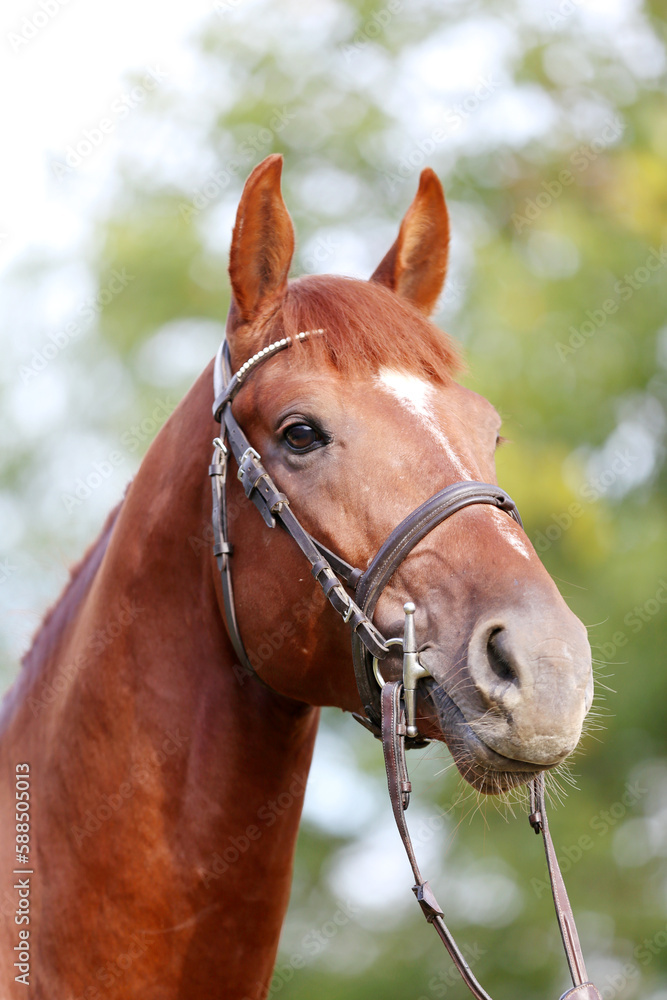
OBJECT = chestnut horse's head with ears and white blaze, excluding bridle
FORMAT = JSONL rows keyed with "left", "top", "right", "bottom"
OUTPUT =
{"left": 217, "top": 156, "right": 593, "bottom": 792}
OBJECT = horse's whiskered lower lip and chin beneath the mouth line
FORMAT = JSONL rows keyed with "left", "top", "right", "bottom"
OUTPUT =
{"left": 420, "top": 681, "right": 549, "bottom": 795}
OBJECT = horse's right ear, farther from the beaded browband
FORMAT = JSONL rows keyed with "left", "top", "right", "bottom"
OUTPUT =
{"left": 370, "top": 167, "right": 449, "bottom": 316}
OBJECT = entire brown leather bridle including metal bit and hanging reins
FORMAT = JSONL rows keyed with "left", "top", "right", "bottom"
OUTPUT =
{"left": 209, "top": 330, "right": 602, "bottom": 1000}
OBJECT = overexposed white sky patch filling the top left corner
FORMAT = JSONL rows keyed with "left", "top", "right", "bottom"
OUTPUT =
{"left": 0, "top": 0, "right": 213, "bottom": 270}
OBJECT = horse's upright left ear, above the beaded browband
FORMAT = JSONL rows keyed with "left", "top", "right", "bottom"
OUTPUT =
{"left": 227, "top": 154, "right": 294, "bottom": 346}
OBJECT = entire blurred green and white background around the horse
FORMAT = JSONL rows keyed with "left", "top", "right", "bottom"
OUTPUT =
{"left": 0, "top": 0, "right": 667, "bottom": 1000}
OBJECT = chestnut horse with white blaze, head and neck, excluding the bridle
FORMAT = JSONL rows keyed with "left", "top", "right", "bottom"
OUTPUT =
{"left": 0, "top": 156, "right": 592, "bottom": 1000}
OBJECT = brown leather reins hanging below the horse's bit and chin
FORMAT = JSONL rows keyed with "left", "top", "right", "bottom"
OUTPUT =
{"left": 381, "top": 681, "right": 602, "bottom": 1000}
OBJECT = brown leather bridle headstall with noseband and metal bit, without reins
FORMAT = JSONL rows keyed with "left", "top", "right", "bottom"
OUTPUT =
{"left": 209, "top": 330, "right": 521, "bottom": 746}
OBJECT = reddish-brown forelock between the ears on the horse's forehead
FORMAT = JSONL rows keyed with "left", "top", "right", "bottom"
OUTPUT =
{"left": 266, "top": 275, "right": 463, "bottom": 384}
